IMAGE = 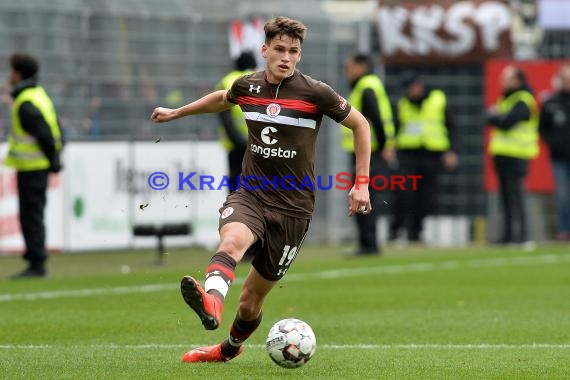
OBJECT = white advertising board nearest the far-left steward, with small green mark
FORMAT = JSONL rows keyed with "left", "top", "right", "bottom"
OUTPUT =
{"left": 62, "top": 142, "right": 131, "bottom": 251}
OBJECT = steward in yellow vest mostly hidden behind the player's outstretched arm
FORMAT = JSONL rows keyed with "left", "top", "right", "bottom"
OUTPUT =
{"left": 216, "top": 51, "right": 257, "bottom": 193}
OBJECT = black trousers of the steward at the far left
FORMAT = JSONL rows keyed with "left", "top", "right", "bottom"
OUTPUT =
{"left": 18, "top": 170, "right": 48, "bottom": 270}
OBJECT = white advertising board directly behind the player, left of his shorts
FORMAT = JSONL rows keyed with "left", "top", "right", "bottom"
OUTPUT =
{"left": 130, "top": 142, "right": 227, "bottom": 247}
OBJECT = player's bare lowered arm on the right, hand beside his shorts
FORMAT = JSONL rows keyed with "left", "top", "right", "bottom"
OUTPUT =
{"left": 342, "top": 108, "right": 372, "bottom": 216}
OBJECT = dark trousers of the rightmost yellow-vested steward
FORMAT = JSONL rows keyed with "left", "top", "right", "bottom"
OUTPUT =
{"left": 493, "top": 156, "right": 528, "bottom": 243}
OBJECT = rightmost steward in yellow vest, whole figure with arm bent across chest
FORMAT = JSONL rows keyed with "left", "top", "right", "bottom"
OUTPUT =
{"left": 487, "top": 65, "right": 539, "bottom": 247}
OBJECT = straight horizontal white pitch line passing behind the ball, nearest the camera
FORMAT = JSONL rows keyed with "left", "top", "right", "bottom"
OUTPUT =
{"left": 0, "top": 343, "right": 570, "bottom": 350}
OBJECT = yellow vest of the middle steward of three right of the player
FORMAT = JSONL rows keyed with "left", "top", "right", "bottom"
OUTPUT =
{"left": 396, "top": 90, "right": 450, "bottom": 152}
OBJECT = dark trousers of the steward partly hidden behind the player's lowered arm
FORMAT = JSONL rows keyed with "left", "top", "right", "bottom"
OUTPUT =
{"left": 352, "top": 152, "right": 381, "bottom": 252}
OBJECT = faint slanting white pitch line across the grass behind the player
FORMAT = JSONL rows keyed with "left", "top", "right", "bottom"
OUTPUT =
{"left": 0, "top": 254, "right": 570, "bottom": 302}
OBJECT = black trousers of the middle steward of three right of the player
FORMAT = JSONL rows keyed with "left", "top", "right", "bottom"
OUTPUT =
{"left": 390, "top": 150, "right": 442, "bottom": 241}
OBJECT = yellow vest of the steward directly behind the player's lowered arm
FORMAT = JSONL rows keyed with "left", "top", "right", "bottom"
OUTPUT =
{"left": 341, "top": 74, "right": 395, "bottom": 152}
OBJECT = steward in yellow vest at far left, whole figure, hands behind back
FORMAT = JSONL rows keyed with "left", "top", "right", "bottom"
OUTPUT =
{"left": 4, "top": 53, "right": 62, "bottom": 278}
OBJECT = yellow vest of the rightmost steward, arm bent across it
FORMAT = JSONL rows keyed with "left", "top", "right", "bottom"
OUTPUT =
{"left": 489, "top": 90, "right": 539, "bottom": 160}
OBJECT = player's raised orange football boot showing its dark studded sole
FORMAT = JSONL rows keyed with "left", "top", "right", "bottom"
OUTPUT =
{"left": 180, "top": 276, "right": 224, "bottom": 330}
